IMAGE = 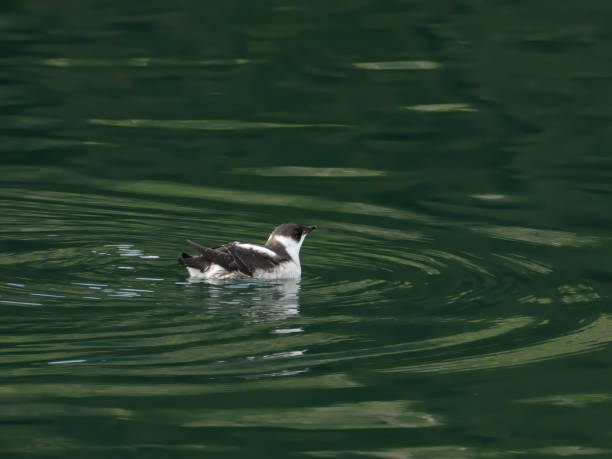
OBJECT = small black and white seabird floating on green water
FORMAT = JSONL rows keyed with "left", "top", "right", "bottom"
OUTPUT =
{"left": 179, "top": 223, "right": 317, "bottom": 279}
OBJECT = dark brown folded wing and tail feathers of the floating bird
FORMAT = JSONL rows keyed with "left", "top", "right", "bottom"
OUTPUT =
{"left": 179, "top": 241, "right": 282, "bottom": 276}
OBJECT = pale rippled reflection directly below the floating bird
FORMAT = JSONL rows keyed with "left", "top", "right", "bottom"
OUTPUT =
{"left": 191, "top": 279, "right": 300, "bottom": 323}
